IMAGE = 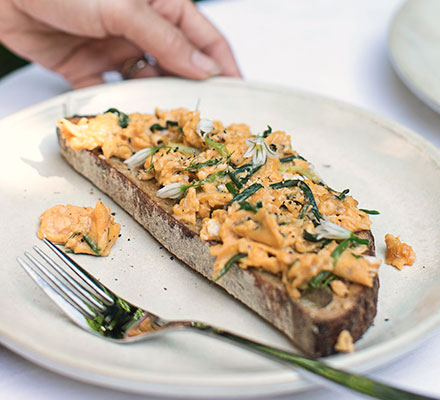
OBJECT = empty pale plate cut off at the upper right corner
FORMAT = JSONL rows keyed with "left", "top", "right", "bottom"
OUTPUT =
{"left": 388, "top": 0, "right": 440, "bottom": 112}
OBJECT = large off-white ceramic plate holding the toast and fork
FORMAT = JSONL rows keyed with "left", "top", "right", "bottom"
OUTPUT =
{"left": 0, "top": 78, "right": 440, "bottom": 398}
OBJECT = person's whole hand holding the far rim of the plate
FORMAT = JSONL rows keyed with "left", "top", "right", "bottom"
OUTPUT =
{"left": 0, "top": 0, "right": 240, "bottom": 88}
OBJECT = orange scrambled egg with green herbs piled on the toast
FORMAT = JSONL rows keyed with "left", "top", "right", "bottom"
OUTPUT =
{"left": 58, "top": 109, "right": 380, "bottom": 298}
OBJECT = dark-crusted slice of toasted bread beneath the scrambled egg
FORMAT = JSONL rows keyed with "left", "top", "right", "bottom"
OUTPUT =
{"left": 58, "top": 118, "right": 379, "bottom": 357}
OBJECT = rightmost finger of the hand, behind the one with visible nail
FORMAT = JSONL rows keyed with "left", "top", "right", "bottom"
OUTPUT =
{"left": 151, "top": 0, "right": 241, "bottom": 76}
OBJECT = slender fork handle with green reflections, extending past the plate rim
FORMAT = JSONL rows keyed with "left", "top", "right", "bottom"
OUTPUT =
{"left": 187, "top": 322, "right": 435, "bottom": 400}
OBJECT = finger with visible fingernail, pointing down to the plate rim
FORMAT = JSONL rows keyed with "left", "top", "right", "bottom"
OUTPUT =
{"left": 101, "top": 0, "right": 221, "bottom": 79}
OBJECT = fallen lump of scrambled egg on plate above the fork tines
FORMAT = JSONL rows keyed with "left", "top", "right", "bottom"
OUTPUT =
{"left": 37, "top": 201, "right": 121, "bottom": 256}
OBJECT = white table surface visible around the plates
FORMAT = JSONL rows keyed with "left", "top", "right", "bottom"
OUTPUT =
{"left": 0, "top": 0, "right": 440, "bottom": 400}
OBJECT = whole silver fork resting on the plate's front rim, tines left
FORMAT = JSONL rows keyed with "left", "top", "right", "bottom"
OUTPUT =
{"left": 17, "top": 239, "right": 434, "bottom": 400}
